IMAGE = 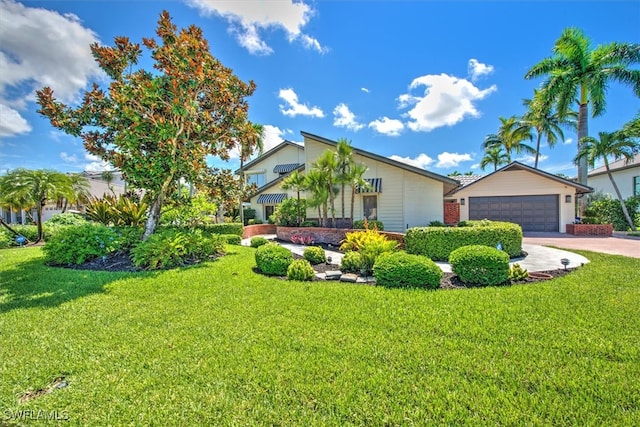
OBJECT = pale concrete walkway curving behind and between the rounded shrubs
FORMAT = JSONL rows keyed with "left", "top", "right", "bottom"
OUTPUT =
{"left": 242, "top": 234, "right": 592, "bottom": 273}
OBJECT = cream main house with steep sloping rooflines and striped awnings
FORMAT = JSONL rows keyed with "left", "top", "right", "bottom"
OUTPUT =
{"left": 238, "top": 132, "right": 459, "bottom": 232}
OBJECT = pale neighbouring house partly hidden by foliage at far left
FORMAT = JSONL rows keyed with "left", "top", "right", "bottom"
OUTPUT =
{"left": 0, "top": 171, "right": 125, "bottom": 224}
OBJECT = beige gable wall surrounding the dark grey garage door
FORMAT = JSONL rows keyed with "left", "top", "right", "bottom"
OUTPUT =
{"left": 447, "top": 170, "right": 575, "bottom": 233}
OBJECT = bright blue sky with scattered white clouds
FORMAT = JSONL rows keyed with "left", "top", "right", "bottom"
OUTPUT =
{"left": 0, "top": 0, "right": 640, "bottom": 176}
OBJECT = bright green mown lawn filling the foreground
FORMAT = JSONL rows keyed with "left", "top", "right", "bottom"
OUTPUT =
{"left": 0, "top": 246, "right": 640, "bottom": 426}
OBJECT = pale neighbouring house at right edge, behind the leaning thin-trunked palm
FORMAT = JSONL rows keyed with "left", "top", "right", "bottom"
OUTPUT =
{"left": 587, "top": 154, "right": 640, "bottom": 200}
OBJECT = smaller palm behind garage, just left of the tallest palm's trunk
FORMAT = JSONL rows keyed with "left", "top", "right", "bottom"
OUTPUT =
{"left": 522, "top": 89, "right": 578, "bottom": 169}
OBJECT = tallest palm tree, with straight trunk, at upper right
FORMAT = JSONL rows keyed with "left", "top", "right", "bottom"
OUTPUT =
{"left": 524, "top": 28, "right": 640, "bottom": 185}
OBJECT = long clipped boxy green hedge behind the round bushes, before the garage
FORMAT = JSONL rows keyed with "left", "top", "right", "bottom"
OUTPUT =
{"left": 404, "top": 220, "right": 522, "bottom": 261}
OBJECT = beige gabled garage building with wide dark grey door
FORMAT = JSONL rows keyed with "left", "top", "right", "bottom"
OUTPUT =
{"left": 447, "top": 162, "right": 593, "bottom": 233}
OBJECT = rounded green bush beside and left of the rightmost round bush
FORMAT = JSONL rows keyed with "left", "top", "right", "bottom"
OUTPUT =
{"left": 373, "top": 252, "right": 442, "bottom": 289}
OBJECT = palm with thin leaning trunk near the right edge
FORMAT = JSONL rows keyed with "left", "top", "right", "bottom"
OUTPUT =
{"left": 575, "top": 131, "right": 640, "bottom": 231}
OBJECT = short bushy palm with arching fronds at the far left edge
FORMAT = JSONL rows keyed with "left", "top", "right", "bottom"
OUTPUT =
{"left": 0, "top": 169, "right": 72, "bottom": 243}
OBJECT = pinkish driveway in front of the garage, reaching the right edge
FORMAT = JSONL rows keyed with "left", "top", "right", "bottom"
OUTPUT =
{"left": 522, "top": 232, "right": 640, "bottom": 258}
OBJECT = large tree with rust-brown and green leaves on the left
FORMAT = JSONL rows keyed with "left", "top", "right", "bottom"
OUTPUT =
{"left": 37, "top": 11, "right": 257, "bottom": 239}
